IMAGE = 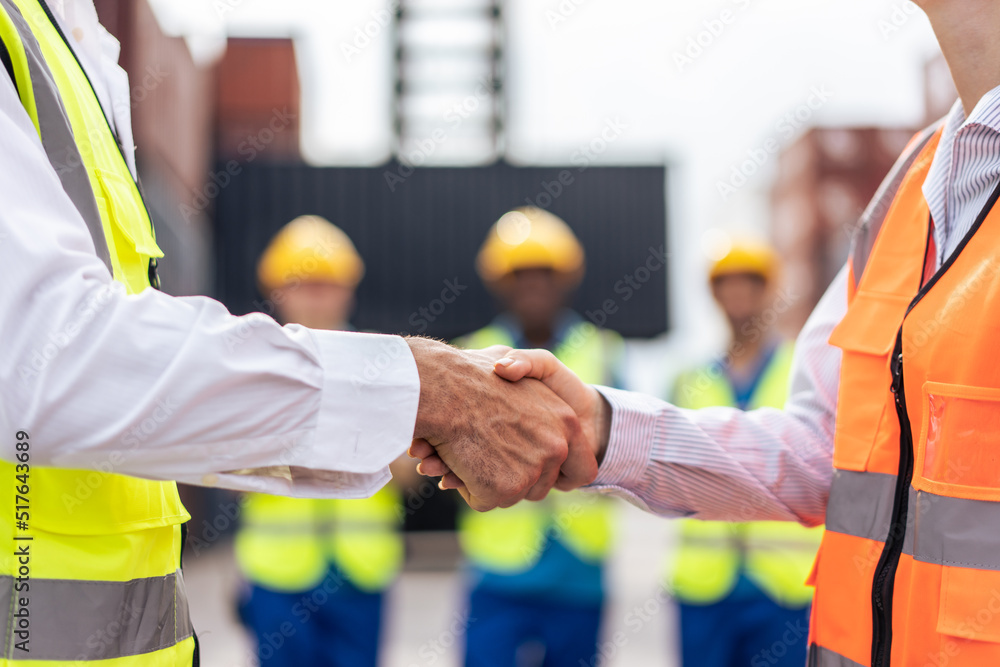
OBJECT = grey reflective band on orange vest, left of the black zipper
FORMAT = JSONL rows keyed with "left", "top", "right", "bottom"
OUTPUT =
{"left": 826, "top": 470, "right": 896, "bottom": 542}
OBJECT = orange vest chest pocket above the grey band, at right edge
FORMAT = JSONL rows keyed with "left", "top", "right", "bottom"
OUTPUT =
{"left": 913, "top": 382, "right": 1000, "bottom": 502}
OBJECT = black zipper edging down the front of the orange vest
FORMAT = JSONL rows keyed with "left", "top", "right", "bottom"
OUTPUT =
{"left": 871, "top": 182, "right": 1000, "bottom": 667}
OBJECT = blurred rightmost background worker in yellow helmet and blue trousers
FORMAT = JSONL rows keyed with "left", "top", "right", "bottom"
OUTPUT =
{"left": 667, "top": 242, "right": 822, "bottom": 667}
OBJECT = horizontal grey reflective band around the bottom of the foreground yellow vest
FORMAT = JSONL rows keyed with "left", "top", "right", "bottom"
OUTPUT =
{"left": 0, "top": 571, "right": 193, "bottom": 661}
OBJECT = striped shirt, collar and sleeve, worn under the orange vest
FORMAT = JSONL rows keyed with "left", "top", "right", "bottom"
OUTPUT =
{"left": 592, "top": 88, "right": 1000, "bottom": 525}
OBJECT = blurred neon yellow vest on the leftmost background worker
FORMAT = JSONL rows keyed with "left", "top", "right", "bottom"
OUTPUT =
{"left": 236, "top": 485, "right": 403, "bottom": 593}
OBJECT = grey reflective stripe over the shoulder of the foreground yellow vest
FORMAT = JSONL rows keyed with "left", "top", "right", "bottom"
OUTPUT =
{"left": 0, "top": 0, "right": 112, "bottom": 271}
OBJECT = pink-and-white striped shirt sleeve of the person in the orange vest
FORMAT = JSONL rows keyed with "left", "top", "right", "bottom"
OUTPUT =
{"left": 592, "top": 268, "right": 847, "bottom": 525}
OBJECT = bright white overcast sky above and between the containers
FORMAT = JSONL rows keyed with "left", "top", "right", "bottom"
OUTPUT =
{"left": 146, "top": 0, "right": 938, "bottom": 394}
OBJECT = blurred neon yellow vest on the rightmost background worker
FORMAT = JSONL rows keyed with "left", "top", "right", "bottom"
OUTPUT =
{"left": 667, "top": 343, "right": 823, "bottom": 608}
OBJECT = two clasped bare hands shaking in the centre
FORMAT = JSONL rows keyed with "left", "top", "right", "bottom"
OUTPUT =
{"left": 407, "top": 338, "right": 611, "bottom": 511}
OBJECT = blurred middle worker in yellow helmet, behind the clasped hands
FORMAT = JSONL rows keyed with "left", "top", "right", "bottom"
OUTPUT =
{"left": 457, "top": 208, "right": 623, "bottom": 667}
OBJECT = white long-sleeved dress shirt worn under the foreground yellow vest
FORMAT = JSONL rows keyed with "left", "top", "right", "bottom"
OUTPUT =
{"left": 0, "top": 0, "right": 420, "bottom": 497}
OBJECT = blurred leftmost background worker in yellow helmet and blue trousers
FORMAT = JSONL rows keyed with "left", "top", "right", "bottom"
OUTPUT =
{"left": 236, "top": 215, "right": 413, "bottom": 667}
